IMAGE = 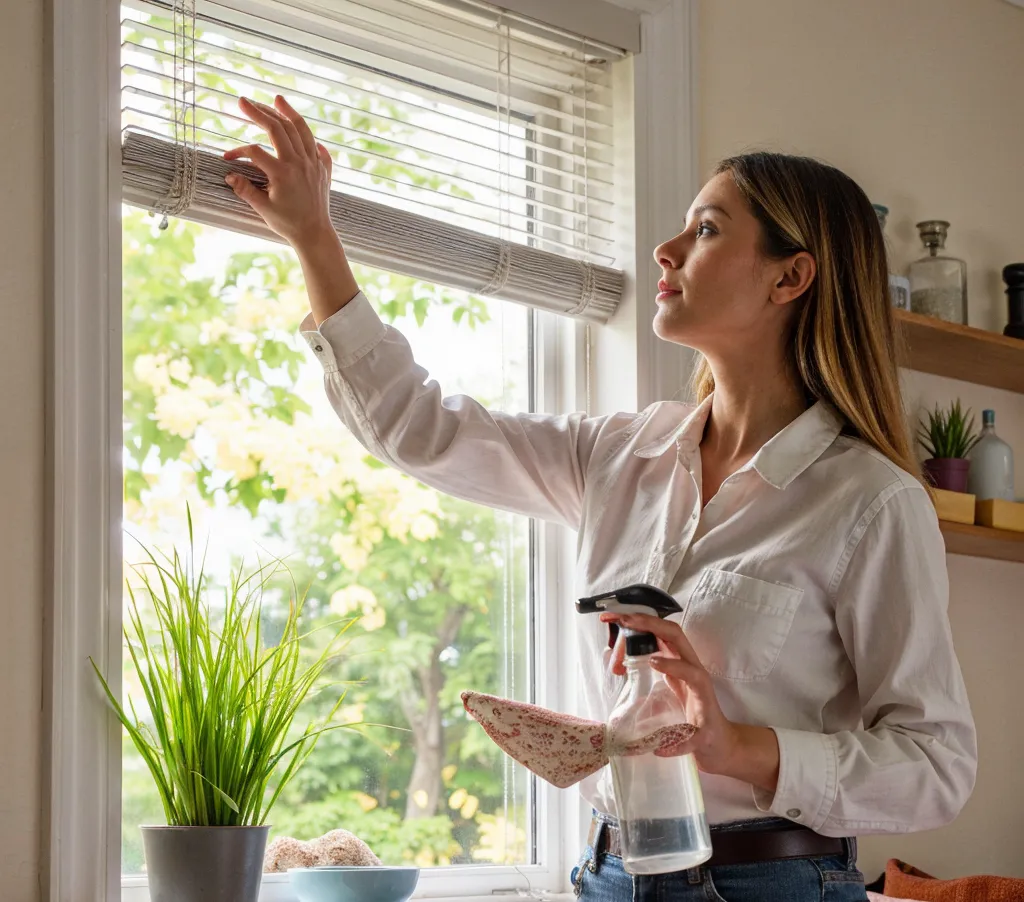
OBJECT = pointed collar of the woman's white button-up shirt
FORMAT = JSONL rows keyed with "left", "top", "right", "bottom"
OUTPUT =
{"left": 634, "top": 395, "right": 843, "bottom": 488}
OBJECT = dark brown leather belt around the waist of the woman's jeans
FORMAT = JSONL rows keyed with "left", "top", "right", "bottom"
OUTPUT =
{"left": 587, "top": 817, "right": 846, "bottom": 867}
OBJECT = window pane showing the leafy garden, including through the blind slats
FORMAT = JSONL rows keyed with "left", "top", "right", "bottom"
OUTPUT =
{"left": 116, "top": 0, "right": 614, "bottom": 898}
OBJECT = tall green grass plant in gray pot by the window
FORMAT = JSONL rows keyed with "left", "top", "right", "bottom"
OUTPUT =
{"left": 92, "top": 514, "right": 351, "bottom": 902}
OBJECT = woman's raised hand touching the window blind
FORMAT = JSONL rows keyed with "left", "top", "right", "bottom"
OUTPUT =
{"left": 224, "top": 94, "right": 336, "bottom": 253}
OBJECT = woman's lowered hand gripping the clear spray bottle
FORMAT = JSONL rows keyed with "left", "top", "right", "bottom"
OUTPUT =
{"left": 601, "top": 612, "right": 779, "bottom": 791}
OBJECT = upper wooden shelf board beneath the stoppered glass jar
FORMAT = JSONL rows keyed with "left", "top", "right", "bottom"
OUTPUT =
{"left": 896, "top": 310, "right": 1024, "bottom": 393}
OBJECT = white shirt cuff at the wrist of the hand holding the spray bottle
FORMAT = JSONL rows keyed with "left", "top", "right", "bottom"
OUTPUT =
{"left": 754, "top": 727, "right": 839, "bottom": 830}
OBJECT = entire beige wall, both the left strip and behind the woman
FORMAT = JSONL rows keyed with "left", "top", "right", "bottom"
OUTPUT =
{"left": 0, "top": 0, "right": 1024, "bottom": 888}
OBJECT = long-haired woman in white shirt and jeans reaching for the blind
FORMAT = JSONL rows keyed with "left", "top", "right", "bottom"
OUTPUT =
{"left": 225, "top": 98, "right": 976, "bottom": 902}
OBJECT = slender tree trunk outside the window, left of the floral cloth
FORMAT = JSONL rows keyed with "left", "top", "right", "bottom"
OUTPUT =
{"left": 401, "top": 606, "right": 468, "bottom": 820}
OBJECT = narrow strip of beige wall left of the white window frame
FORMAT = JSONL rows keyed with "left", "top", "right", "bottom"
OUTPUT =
{"left": 0, "top": 0, "right": 45, "bottom": 902}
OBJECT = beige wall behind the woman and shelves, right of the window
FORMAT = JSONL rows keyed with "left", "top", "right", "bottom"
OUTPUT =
{"left": 699, "top": 0, "right": 1024, "bottom": 877}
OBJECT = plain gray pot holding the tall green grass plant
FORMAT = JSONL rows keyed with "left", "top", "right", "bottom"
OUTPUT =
{"left": 141, "top": 826, "right": 270, "bottom": 902}
